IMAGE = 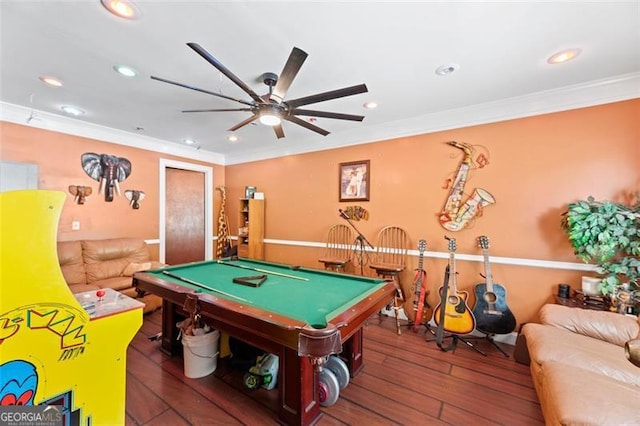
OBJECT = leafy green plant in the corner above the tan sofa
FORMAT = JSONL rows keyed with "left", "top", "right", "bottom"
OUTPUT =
{"left": 561, "top": 196, "right": 640, "bottom": 296}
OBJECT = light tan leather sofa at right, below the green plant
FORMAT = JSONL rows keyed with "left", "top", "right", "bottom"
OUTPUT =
{"left": 521, "top": 304, "right": 640, "bottom": 425}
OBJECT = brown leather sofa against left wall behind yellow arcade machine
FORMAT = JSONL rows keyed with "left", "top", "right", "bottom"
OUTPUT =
{"left": 58, "top": 238, "right": 162, "bottom": 313}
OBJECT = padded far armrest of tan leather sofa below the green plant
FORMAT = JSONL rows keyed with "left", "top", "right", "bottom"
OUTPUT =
{"left": 540, "top": 304, "right": 639, "bottom": 347}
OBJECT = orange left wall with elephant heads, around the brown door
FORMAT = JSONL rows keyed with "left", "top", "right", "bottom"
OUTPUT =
{"left": 0, "top": 122, "right": 225, "bottom": 259}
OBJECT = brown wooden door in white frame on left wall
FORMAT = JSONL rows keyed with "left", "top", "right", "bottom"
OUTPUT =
{"left": 165, "top": 167, "right": 205, "bottom": 265}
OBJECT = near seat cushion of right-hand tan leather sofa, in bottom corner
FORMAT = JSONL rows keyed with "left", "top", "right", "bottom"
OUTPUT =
{"left": 532, "top": 362, "right": 640, "bottom": 425}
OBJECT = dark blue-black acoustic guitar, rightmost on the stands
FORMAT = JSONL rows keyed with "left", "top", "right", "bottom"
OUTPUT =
{"left": 473, "top": 235, "right": 516, "bottom": 334}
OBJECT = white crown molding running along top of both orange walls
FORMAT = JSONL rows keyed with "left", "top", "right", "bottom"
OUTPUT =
{"left": 0, "top": 72, "right": 640, "bottom": 165}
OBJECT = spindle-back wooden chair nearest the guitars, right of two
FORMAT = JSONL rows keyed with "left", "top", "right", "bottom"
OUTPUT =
{"left": 369, "top": 226, "right": 411, "bottom": 334}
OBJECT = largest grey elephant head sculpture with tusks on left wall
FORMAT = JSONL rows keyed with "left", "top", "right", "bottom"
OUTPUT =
{"left": 81, "top": 152, "right": 131, "bottom": 202}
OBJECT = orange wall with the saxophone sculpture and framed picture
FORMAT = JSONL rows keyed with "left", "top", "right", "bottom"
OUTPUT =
{"left": 226, "top": 100, "right": 640, "bottom": 322}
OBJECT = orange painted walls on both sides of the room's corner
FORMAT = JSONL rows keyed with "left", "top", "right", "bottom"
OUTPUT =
{"left": 0, "top": 100, "right": 640, "bottom": 322}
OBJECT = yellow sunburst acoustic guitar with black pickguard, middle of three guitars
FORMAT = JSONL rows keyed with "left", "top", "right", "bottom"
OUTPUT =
{"left": 433, "top": 237, "right": 476, "bottom": 334}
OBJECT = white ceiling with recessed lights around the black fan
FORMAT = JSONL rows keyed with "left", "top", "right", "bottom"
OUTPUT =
{"left": 0, "top": 0, "right": 640, "bottom": 164}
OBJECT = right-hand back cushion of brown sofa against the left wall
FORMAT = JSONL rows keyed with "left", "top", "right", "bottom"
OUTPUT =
{"left": 82, "top": 238, "right": 151, "bottom": 284}
